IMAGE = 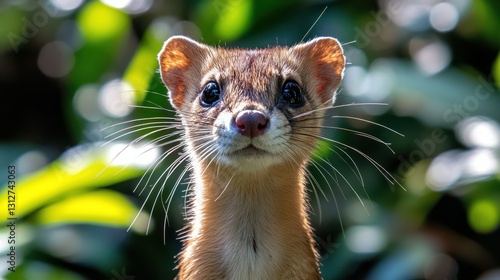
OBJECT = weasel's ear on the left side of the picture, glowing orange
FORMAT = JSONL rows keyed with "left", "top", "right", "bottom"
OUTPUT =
{"left": 158, "top": 36, "right": 210, "bottom": 110}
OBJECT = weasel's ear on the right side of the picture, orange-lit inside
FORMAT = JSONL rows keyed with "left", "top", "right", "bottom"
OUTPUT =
{"left": 290, "top": 37, "right": 345, "bottom": 102}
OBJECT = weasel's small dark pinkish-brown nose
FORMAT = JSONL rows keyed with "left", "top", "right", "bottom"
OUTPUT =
{"left": 235, "top": 110, "right": 267, "bottom": 138}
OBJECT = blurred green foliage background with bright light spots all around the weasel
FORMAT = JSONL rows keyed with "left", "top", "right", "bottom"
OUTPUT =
{"left": 0, "top": 0, "right": 500, "bottom": 280}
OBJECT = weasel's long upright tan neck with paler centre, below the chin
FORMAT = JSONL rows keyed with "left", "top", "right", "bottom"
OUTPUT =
{"left": 180, "top": 161, "right": 320, "bottom": 279}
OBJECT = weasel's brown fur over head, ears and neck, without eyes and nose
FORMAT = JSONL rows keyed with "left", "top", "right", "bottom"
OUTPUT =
{"left": 159, "top": 36, "right": 345, "bottom": 280}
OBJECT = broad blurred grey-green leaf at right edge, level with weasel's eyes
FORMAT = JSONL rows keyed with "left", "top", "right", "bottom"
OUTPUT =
{"left": 370, "top": 59, "right": 500, "bottom": 128}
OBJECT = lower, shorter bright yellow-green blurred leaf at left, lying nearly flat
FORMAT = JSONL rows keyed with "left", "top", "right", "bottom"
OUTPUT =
{"left": 35, "top": 190, "right": 138, "bottom": 227}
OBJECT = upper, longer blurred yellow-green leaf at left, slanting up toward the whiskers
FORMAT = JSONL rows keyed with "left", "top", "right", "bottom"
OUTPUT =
{"left": 0, "top": 145, "right": 144, "bottom": 221}
